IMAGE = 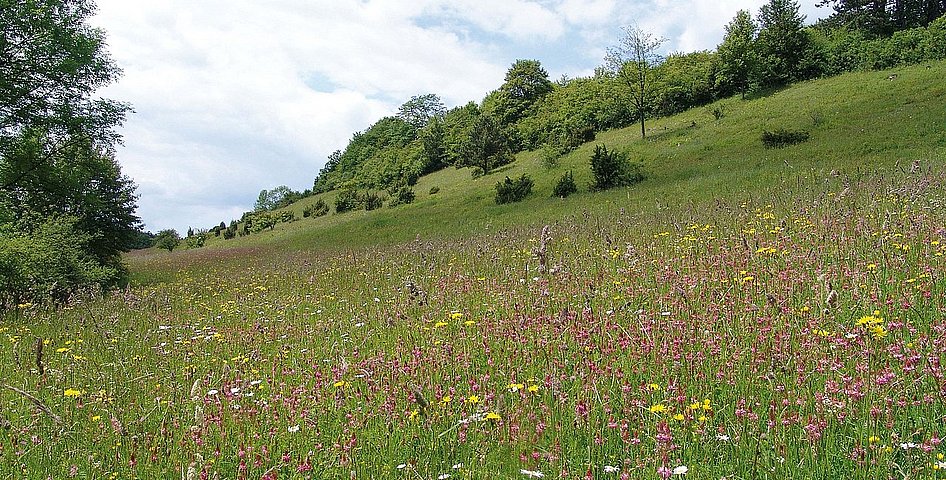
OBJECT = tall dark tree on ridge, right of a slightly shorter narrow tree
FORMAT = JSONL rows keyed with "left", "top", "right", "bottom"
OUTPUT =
{"left": 757, "top": 0, "right": 811, "bottom": 87}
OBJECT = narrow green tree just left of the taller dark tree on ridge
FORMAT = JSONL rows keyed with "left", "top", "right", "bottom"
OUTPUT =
{"left": 716, "top": 10, "right": 758, "bottom": 98}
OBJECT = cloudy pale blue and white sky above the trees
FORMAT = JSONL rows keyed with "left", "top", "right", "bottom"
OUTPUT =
{"left": 92, "top": 0, "right": 828, "bottom": 231}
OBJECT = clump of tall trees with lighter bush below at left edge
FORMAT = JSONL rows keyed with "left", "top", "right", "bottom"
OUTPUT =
{"left": 0, "top": 0, "right": 141, "bottom": 308}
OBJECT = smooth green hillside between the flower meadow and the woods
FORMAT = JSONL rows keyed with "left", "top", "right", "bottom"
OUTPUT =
{"left": 162, "top": 62, "right": 946, "bottom": 260}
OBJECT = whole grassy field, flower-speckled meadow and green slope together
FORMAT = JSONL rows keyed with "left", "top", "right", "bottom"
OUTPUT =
{"left": 0, "top": 63, "right": 946, "bottom": 480}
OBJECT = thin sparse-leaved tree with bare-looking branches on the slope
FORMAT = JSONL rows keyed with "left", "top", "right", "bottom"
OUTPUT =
{"left": 604, "top": 26, "right": 667, "bottom": 138}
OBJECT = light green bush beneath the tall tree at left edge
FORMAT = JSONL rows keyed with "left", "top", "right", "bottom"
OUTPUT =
{"left": 0, "top": 217, "right": 116, "bottom": 308}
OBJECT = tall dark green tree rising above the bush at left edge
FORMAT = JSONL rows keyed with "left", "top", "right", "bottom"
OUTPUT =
{"left": 0, "top": 0, "right": 140, "bottom": 292}
